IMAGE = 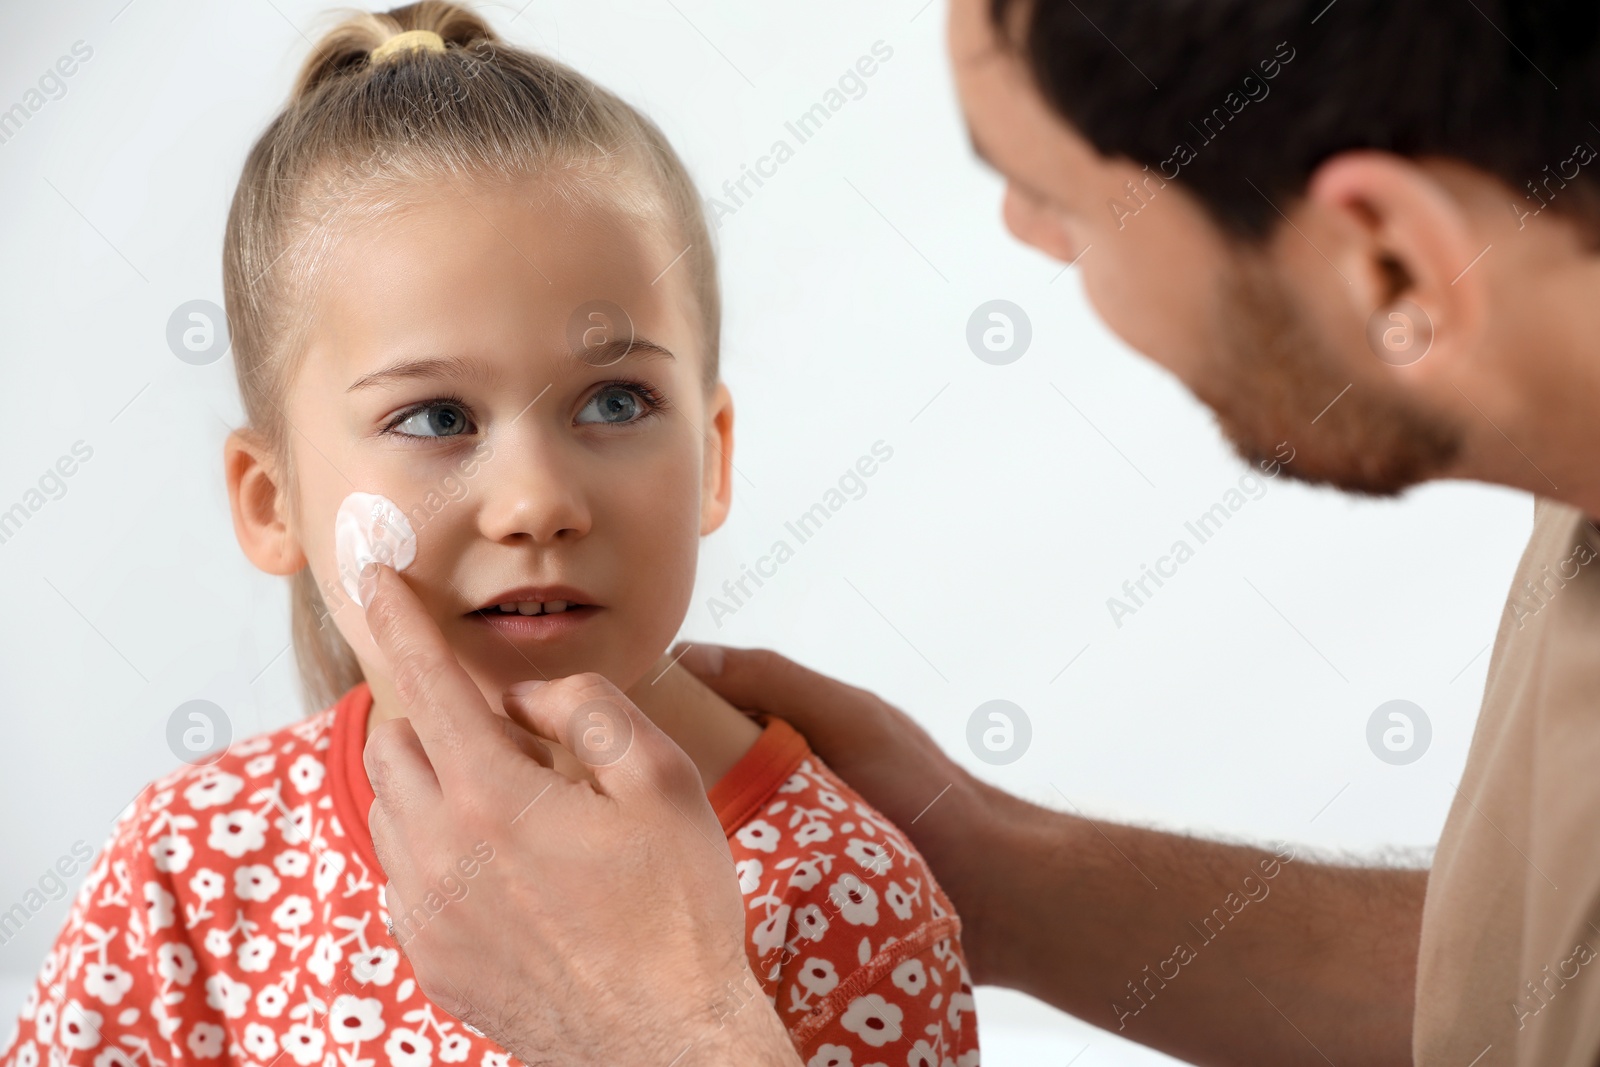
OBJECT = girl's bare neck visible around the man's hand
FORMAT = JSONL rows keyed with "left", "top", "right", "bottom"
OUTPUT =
{"left": 366, "top": 656, "right": 762, "bottom": 789}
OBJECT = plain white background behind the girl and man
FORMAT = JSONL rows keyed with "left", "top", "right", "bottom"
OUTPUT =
{"left": 0, "top": 0, "right": 1533, "bottom": 1067}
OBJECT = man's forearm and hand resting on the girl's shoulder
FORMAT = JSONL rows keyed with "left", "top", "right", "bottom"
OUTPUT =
{"left": 680, "top": 645, "right": 1427, "bottom": 1067}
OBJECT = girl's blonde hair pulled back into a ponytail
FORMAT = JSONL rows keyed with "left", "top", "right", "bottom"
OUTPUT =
{"left": 222, "top": 0, "right": 722, "bottom": 710}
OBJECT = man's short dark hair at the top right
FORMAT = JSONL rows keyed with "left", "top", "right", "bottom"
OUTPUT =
{"left": 989, "top": 0, "right": 1600, "bottom": 238}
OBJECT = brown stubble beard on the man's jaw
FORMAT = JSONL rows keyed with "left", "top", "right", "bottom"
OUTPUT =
{"left": 1194, "top": 251, "right": 1462, "bottom": 496}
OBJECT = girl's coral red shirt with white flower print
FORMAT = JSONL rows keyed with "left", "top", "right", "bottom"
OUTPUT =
{"left": 0, "top": 683, "right": 978, "bottom": 1067}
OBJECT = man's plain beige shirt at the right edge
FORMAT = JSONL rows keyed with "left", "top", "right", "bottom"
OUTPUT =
{"left": 1413, "top": 499, "right": 1600, "bottom": 1067}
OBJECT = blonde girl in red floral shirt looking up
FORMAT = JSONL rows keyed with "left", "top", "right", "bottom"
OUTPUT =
{"left": 0, "top": 0, "right": 978, "bottom": 1067}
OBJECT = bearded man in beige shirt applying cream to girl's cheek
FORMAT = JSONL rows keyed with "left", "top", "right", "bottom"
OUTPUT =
{"left": 356, "top": 0, "right": 1600, "bottom": 1067}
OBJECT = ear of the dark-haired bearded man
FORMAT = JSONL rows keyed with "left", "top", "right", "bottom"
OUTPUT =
{"left": 1306, "top": 150, "right": 1490, "bottom": 379}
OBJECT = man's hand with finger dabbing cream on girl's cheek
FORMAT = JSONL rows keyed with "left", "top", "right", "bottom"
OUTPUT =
{"left": 363, "top": 566, "right": 800, "bottom": 1067}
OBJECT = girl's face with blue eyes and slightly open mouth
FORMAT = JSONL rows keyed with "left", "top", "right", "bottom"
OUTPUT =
{"left": 268, "top": 181, "right": 733, "bottom": 704}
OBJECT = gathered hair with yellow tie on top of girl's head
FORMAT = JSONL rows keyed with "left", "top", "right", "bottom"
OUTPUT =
{"left": 290, "top": 0, "right": 499, "bottom": 101}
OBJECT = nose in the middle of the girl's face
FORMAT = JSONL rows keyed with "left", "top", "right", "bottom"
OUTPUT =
{"left": 478, "top": 437, "right": 592, "bottom": 545}
